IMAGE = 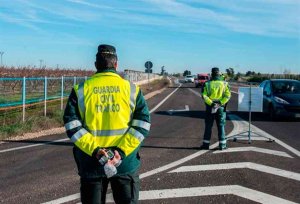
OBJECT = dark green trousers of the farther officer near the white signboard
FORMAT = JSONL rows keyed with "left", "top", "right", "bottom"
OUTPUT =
{"left": 203, "top": 105, "right": 226, "bottom": 148}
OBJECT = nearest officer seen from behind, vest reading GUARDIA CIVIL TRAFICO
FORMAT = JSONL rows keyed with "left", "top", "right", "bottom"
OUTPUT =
{"left": 63, "top": 45, "right": 150, "bottom": 204}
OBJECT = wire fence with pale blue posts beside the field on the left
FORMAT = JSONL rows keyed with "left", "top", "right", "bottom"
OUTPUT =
{"left": 0, "top": 76, "right": 87, "bottom": 124}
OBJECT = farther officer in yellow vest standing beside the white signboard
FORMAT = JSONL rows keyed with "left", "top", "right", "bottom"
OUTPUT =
{"left": 200, "top": 67, "right": 231, "bottom": 150}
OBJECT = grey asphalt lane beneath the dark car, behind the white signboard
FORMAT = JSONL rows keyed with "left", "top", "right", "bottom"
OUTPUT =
{"left": 227, "top": 93, "right": 300, "bottom": 150}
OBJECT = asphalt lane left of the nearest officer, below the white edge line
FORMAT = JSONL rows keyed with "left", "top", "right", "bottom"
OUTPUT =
{"left": 0, "top": 140, "right": 78, "bottom": 203}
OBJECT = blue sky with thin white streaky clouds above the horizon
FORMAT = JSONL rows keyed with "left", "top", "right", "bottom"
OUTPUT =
{"left": 0, "top": 0, "right": 300, "bottom": 74}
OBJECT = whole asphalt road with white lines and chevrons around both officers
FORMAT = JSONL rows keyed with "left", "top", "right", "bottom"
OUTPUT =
{"left": 0, "top": 81, "right": 300, "bottom": 204}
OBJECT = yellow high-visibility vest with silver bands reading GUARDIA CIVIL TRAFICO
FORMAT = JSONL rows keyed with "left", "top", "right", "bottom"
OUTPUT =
{"left": 65, "top": 72, "right": 150, "bottom": 156}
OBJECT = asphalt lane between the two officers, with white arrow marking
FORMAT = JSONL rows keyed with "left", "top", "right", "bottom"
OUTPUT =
{"left": 140, "top": 83, "right": 233, "bottom": 173}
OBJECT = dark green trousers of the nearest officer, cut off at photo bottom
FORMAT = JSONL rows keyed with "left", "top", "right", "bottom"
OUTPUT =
{"left": 80, "top": 174, "right": 140, "bottom": 204}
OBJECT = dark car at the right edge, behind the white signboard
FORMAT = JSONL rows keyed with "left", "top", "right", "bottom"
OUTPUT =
{"left": 259, "top": 79, "right": 300, "bottom": 119}
